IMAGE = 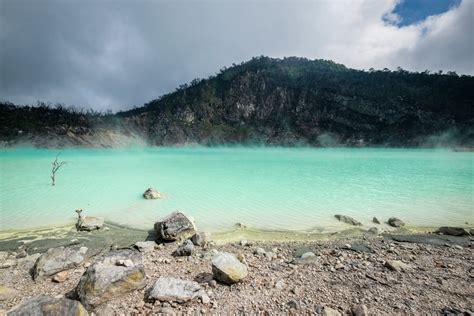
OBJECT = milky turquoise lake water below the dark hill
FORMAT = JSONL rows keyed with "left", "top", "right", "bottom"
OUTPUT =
{"left": 0, "top": 147, "right": 474, "bottom": 232}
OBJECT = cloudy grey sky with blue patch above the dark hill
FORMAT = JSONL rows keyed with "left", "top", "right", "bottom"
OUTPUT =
{"left": 0, "top": 0, "right": 474, "bottom": 110}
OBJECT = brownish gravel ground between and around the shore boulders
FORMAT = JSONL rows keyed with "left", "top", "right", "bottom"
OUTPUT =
{"left": 0, "top": 234, "right": 474, "bottom": 315}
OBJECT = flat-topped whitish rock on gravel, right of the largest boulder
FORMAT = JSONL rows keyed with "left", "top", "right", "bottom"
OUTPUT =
{"left": 148, "top": 277, "right": 209, "bottom": 303}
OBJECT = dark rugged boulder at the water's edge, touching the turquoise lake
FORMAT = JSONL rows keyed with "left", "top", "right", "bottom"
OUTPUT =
{"left": 155, "top": 212, "right": 196, "bottom": 241}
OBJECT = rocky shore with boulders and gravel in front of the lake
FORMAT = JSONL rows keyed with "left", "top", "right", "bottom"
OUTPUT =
{"left": 0, "top": 213, "right": 474, "bottom": 315}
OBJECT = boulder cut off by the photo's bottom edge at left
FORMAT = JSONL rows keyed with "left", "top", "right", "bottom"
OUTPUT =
{"left": 7, "top": 295, "right": 89, "bottom": 316}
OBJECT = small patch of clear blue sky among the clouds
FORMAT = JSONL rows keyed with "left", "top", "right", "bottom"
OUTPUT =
{"left": 383, "top": 0, "right": 461, "bottom": 27}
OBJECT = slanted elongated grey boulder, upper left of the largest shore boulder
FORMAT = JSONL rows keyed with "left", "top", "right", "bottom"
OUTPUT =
{"left": 33, "top": 247, "right": 87, "bottom": 280}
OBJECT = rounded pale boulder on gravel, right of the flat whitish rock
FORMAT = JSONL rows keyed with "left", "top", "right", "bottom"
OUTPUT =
{"left": 212, "top": 252, "right": 248, "bottom": 284}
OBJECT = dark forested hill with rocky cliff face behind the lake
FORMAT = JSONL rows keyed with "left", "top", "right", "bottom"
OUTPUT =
{"left": 0, "top": 57, "right": 474, "bottom": 146}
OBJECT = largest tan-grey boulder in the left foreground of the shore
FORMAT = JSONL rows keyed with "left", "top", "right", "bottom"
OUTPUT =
{"left": 76, "top": 249, "right": 146, "bottom": 308}
